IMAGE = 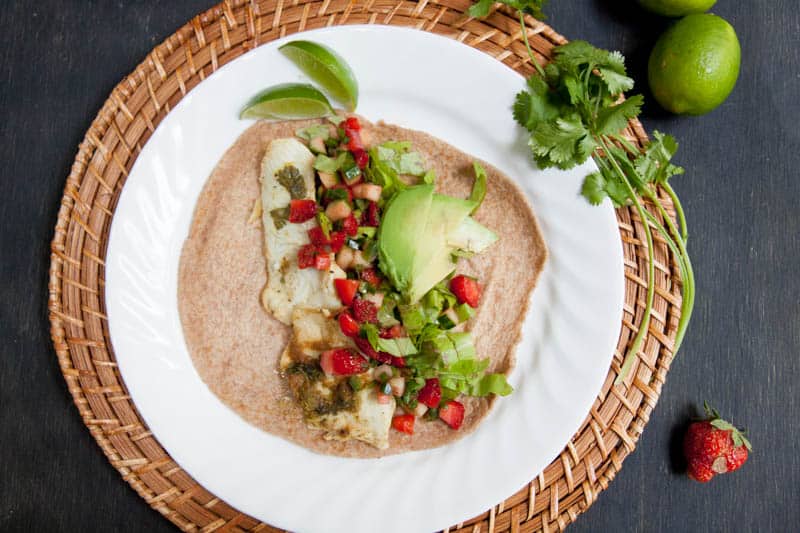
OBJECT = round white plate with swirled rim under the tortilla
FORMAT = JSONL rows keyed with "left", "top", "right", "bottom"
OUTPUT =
{"left": 106, "top": 26, "right": 623, "bottom": 533}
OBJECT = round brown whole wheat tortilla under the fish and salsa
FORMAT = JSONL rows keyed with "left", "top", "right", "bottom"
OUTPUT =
{"left": 178, "top": 121, "right": 547, "bottom": 457}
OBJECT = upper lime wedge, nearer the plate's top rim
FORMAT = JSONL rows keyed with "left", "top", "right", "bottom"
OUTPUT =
{"left": 278, "top": 41, "right": 358, "bottom": 111}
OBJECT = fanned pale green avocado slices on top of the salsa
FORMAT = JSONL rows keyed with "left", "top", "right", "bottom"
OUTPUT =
{"left": 378, "top": 185, "right": 497, "bottom": 303}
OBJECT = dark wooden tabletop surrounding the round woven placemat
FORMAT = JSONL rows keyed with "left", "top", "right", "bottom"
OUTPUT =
{"left": 0, "top": 0, "right": 800, "bottom": 532}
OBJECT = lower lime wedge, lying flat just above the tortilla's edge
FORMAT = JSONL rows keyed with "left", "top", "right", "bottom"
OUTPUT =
{"left": 239, "top": 83, "right": 333, "bottom": 120}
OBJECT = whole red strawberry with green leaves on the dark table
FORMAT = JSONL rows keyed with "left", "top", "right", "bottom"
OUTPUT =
{"left": 683, "top": 404, "right": 753, "bottom": 483}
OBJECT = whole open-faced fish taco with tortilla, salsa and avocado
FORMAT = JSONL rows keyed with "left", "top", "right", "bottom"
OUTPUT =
{"left": 178, "top": 116, "right": 547, "bottom": 457}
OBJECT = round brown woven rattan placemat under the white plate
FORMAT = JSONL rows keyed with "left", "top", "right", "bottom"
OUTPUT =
{"left": 49, "top": 0, "right": 681, "bottom": 532}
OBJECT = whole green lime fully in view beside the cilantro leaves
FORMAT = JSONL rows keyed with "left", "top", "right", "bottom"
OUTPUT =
{"left": 647, "top": 14, "right": 742, "bottom": 115}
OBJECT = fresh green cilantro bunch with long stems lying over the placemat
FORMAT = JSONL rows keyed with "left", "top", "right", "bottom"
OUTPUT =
{"left": 470, "top": 0, "right": 695, "bottom": 384}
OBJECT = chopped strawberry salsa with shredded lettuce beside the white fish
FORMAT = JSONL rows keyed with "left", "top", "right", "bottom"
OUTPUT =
{"left": 288, "top": 117, "right": 512, "bottom": 434}
